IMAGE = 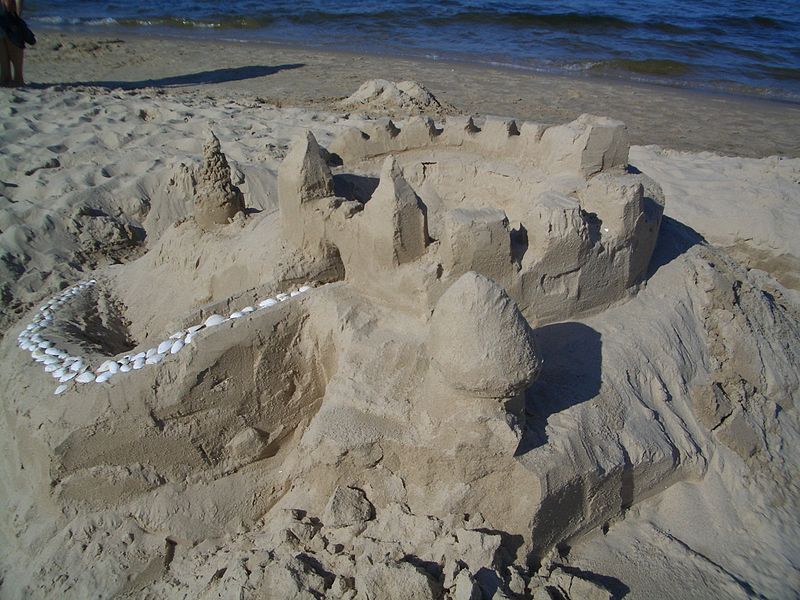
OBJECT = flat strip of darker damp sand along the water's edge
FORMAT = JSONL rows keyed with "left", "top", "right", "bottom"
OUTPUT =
{"left": 18, "top": 30, "right": 800, "bottom": 157}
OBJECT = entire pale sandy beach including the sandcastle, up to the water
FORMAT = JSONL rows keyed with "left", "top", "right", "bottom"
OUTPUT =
{"left": 0, "top": 34, "right": 800, "bottom": 599}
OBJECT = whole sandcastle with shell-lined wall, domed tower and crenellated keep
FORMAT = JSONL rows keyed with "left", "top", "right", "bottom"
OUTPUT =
{"left": 4, "top": 116, "right": 683, "bottom": 600}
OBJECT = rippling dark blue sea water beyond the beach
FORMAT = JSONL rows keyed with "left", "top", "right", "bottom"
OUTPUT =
{"left": 24, "top": 0, "right": 800, "bottom": 102}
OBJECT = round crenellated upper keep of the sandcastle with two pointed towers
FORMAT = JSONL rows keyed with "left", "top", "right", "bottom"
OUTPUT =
{"left": 278, "top": 115, "right": 663, "bottom": 324}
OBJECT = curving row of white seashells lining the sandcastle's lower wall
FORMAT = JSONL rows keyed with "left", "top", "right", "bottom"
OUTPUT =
{"left": 17, "top": 279, "right": 312, "bottom": 395}
